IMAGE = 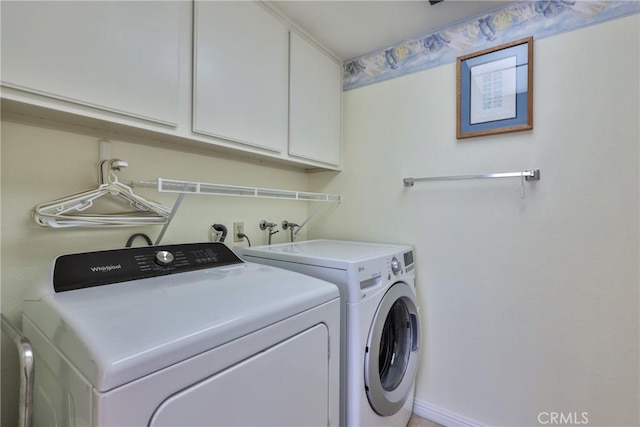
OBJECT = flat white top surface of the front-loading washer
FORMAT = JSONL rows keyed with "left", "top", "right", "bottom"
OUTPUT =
{"left": 242, "top": 240, "right": 411, "bottom": 270}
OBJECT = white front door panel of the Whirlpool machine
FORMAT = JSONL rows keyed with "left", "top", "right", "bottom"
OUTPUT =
{"left": 149, "top": 324, "right": 332, "bottom": 427}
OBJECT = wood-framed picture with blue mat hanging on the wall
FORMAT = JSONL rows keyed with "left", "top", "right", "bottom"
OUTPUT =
{"left": 456, "top": 37, "right": 533, "bottom": 139}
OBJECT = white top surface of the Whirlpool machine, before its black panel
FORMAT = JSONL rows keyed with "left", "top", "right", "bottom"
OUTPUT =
{"left": 24, "top": 263, "right": 338, "bottom": 392}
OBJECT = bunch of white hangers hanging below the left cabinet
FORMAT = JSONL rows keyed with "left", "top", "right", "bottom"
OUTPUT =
{"left": 33, "top": 159, "right": 171, "bottom": 228}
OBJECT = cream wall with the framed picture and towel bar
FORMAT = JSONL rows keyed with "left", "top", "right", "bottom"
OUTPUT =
{"left": 309, "top": 15, "right": 640, "bottom": 426}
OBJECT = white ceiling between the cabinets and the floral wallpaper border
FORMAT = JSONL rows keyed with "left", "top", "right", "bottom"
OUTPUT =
{"left": 269, "top": 0, "right": 516, "bottom": 60}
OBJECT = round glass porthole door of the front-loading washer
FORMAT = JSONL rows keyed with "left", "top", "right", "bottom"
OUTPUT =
{"left": 364, "top": 282, "right": 420, "bottom": 416}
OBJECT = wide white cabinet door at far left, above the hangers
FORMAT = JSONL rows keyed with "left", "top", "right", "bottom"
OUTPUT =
{"left": 1, "top": 1, "right": 180, "bottom": 125}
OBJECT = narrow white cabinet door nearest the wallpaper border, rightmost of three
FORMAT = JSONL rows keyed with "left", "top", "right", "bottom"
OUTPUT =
{"left": 289, "top": 32, "right": 342, "bottom": 166}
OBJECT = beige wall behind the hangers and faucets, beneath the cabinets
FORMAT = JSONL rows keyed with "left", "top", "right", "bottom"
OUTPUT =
{"left": 0, "top": 121, "right": 309, "bottom": 426}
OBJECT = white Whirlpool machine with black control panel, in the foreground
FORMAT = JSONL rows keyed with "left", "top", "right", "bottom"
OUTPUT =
{"left": 23, "top": 243, "right": 340, "bottom": 427}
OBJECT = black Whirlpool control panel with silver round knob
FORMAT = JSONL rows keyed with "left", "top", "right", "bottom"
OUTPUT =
{"left": 53, "top": 242, "right": 244, "bottom": 292}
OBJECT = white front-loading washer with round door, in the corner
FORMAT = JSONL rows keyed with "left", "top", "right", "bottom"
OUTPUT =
{"left": 242, "top": 240, "right": 420, "bottom": 427}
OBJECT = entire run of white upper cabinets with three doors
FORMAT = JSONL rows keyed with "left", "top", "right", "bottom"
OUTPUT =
{"left": 0, "top": 1, "right": 342, "bottom": 170}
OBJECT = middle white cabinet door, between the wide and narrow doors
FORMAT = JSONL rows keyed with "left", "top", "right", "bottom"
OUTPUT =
{"left": 193, "top": 1, "right": 288, "bottom": 152}
